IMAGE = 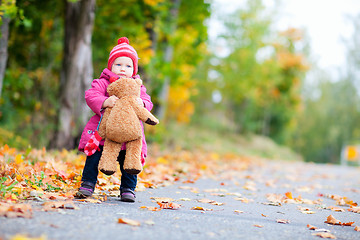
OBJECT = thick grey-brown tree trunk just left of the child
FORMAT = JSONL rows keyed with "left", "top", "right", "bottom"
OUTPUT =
{"left": 55, "top": 0, "right": 95, "bottom": 149}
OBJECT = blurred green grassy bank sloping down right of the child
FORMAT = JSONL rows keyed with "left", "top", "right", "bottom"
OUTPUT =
{"left": 153, "top": 124, "right": 302, "bottom": 161}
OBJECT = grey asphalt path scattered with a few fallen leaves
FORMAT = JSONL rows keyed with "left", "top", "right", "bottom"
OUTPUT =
{"left": 0, "top": 161, "right": 360, "bottom": 240}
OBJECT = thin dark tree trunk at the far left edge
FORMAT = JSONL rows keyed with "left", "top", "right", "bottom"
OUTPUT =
{"left": 0, "top": 12, "right": 10, "bottom": 98}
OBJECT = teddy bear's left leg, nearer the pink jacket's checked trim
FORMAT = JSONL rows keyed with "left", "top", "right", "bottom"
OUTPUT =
{"left": 99, "top": 139, "right": 121, "bottom": 175}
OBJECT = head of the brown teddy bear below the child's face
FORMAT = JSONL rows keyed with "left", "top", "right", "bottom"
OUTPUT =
{"left": 107, "top": 78, "right": 142, "bottom": 98}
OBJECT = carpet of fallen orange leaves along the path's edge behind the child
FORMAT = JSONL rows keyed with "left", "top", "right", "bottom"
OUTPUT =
{"left": 0, "top": 145, "right": 250, "bottom": 204}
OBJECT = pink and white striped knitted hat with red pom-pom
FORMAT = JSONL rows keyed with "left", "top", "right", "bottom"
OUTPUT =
{"left": 108, "top": 37, "right": 139, "bottom": 76}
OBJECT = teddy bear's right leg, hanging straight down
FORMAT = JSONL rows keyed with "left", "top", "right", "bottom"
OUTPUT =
{"left": 124, "top": 138, "right": 142, "bottom": 175}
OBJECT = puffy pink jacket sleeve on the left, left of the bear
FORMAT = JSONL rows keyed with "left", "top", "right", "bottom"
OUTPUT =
{"left": 85, "top": 79, "right": 108, "bottom": 116}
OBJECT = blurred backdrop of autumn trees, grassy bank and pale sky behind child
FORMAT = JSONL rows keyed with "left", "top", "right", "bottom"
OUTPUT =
{"left": 0, "top": 0, "right": 360, "bottom": 163}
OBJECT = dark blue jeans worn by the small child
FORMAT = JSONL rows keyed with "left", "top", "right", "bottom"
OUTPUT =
{"left": 81, "top": 146, "right": 137, "bottom": 191}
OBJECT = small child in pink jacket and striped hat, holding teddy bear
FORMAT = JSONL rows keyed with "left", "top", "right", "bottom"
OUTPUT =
{"left": 75, "top": 37, "right": 153, "bottom": 202}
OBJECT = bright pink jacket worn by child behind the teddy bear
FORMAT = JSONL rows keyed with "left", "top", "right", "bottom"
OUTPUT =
{"left": 78, "top": 68, "right": 153, "bottom": 164}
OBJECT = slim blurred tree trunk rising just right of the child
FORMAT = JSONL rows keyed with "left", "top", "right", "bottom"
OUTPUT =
{"left": 156, "top": 0, "right": 181, "bottom": 120}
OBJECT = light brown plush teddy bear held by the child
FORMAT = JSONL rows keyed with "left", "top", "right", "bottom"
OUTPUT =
{"left": 98, "top": 78, "right": 159, "bottom": 175}
